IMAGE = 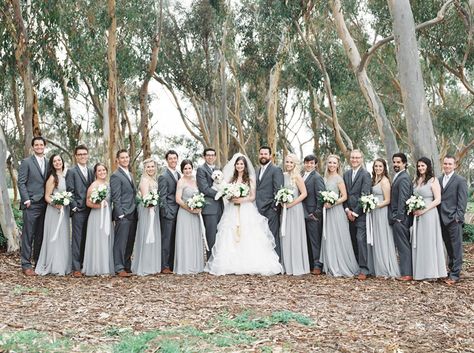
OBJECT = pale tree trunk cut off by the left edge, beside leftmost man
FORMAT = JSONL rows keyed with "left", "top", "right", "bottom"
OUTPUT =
{"left": 0, "top": 127, "right": 20, "bottom": 251}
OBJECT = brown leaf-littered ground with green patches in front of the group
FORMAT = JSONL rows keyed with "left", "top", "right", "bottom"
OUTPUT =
{"left": 0, "top": 244, "right": 474, "bottom": 353}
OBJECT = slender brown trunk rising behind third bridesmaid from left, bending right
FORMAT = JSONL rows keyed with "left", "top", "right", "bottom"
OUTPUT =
{"left": 139, "top": 0, "right": 163, "bottom": 159}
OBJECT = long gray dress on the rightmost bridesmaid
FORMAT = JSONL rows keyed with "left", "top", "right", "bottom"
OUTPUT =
{"left": 411, "top": 179, "right": 448, "bottom": 280}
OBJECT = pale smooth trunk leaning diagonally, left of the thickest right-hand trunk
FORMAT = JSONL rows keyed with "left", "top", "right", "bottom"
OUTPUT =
{"left": 331, "top": 0, "right": 398, "bottom": 164}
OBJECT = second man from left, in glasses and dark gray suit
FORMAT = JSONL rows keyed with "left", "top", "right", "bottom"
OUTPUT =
{"left": 66, "top": 145, "right": 94, "bottom": 277}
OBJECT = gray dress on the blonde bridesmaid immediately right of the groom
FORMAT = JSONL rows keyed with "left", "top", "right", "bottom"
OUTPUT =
{"left": 280, "top": 173, "right": 309, "bottom": 275}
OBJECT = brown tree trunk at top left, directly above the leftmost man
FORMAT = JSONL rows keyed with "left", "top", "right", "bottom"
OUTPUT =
{"left": 10, "top": 0, "right": 37, "bottom": 156}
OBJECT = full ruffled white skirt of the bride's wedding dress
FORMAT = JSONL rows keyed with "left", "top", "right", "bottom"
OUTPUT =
{"left": 204, "top": 184, "right": 282, "bottom": 276}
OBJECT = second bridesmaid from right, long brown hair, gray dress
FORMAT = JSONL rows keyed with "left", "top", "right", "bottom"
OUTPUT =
{"left": 368, "top": 158, "right": 400, "bottom": 278}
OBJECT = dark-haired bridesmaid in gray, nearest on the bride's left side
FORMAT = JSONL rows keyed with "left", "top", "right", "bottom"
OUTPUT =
{"left": 174, "top": 159, "right": 205, "bottom": 275}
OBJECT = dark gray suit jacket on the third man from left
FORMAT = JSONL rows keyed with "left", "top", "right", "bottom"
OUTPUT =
{"left": 110, "top": 167, "right": 137, "bottom": 220}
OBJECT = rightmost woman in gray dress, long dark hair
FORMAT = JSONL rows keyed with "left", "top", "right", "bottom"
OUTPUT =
{"left": 412, "top": 157, "right": 448, "bottom": 280}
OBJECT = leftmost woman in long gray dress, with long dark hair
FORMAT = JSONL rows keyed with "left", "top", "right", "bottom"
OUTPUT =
{"left": 35, "top": 154, "right": 71, "bottom": 275}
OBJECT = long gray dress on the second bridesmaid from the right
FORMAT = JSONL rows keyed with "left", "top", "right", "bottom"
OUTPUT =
{"left": 368, "top": 183, "right": 400, "bottom": 277}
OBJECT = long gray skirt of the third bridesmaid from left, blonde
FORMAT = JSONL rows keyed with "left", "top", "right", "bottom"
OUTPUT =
{"left": 131, "top": 182, "right": 161, "bottom": 276}
